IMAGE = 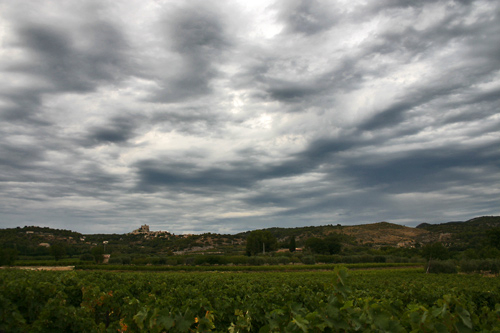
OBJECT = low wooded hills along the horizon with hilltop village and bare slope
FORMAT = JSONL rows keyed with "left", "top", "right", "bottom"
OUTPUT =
{"left": 0, "top": 216, "right": 500, "bottom": 256}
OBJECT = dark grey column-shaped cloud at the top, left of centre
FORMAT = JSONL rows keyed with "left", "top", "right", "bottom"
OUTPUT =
{"left": 146, "top": 2, "right": 229, "bottom": 103}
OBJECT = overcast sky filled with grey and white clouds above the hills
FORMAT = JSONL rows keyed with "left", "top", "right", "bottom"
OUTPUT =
{"left": 0, "top": 0, "right": 500, "bottom": 234}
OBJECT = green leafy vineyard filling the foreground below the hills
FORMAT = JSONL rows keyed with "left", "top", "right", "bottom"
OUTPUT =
{"left": 0, "top": 268, "right": 500, "bottom": 332}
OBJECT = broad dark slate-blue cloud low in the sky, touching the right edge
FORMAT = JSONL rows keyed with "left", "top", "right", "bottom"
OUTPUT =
{"left": 343, "top": 141, "right": 500, "bottom": 193}
